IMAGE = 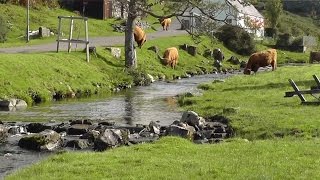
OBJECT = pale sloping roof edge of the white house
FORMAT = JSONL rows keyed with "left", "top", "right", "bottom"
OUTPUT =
{"left": 227, "top": 0, "right": 263, "bottom": 18}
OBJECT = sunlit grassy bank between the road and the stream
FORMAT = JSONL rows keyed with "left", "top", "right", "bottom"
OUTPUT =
{"left": 0, "top": 36, "right": 231, "bottom": 107}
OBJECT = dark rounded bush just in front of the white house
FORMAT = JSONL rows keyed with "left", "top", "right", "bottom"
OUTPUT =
{"left": 216, "top": 25, "right": 256, "bottom": 55}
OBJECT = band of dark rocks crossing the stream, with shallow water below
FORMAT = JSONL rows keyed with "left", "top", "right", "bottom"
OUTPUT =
{"left": 0, "top": 111, "right": 233, "bottom": 176}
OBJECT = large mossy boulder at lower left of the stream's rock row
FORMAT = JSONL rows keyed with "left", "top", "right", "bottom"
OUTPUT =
{"left": 18, "top": 129, "right": 63, "bottom": 151}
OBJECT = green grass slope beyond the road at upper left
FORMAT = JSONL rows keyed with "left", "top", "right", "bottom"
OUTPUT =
{"left": 0, "top": 4, "right": 160, "bottom": 48}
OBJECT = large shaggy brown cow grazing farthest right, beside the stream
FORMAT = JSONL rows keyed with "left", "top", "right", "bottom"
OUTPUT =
{"left": 243, "top": 49, "right": 277, "bottom": 74}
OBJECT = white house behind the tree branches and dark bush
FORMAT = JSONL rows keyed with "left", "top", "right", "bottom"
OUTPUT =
{"left": 182, "top": 0, "right": 264, "bottom": 37}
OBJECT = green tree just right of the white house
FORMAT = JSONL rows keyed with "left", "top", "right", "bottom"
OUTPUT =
{"left": 266, "top": 0, "right": 283, "bottom": 30}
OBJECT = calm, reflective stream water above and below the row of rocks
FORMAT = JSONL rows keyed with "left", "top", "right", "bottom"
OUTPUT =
{"left": 0, "top": 74, "right": 230, "bottom": 179}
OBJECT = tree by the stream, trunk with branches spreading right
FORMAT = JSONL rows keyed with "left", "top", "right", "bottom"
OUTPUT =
{"left": 119, "top": 0, "right": 240, "bottom": 68}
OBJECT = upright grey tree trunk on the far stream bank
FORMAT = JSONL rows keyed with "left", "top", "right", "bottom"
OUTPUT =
{"left": 125, "top": 0, "right": 137, "bottom": 68}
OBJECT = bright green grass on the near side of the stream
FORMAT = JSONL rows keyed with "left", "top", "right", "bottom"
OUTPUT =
{"left": 7, "top": 60, "right": 320, "bottom": 179}
